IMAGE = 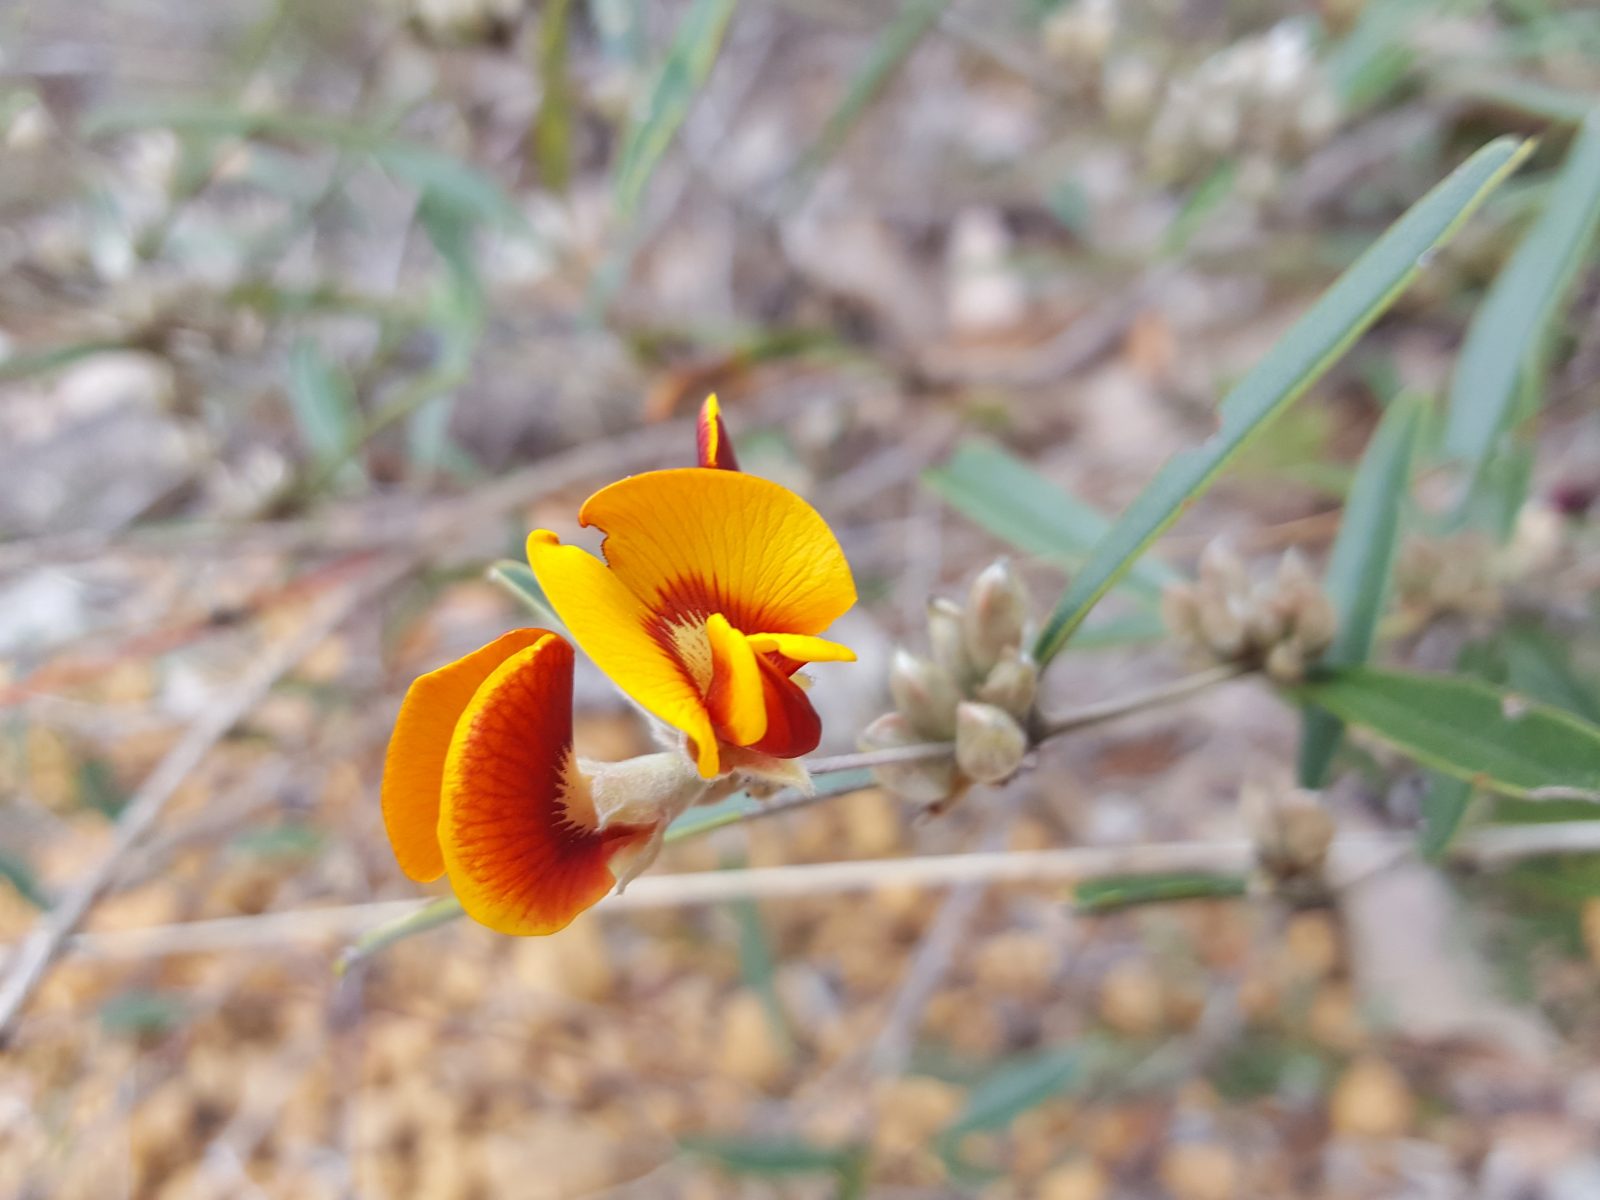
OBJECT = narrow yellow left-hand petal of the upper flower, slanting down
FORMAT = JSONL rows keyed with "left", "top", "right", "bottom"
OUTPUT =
{"left": 528, "top": 534, "right": 723, "bottom": 778}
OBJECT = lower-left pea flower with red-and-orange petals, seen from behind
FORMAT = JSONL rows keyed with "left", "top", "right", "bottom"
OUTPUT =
{"left": 382, "top": 629, "right": 662, "bottom": 934}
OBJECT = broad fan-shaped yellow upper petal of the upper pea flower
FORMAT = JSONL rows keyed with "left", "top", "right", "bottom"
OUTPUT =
{"left": 579, "top": 467, "right": 856, "bottom": 634}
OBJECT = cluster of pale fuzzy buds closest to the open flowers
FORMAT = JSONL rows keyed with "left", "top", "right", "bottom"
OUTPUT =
{"left": 861, "top": 560, "right": 1038, "bottom": 806}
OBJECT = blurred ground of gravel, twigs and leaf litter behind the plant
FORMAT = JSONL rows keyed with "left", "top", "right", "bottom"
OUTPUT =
{"left": 0, "top": 0, "right": 1600, "bottom": 1200}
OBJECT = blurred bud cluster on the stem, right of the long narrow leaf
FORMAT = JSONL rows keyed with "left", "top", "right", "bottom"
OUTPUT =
{"left": 1162, "top": 542, "right": 1338, "bottom": 683}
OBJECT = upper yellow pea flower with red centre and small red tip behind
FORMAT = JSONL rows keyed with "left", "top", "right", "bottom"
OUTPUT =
{"left": 528, "top": 397, "right": 856, "bottom": 778}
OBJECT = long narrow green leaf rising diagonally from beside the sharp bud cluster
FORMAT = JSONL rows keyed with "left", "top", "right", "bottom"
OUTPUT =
{"left": 1034, "top": 138, "right": 1530, "bottom": 664}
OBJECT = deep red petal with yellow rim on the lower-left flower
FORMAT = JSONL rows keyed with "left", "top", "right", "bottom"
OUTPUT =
{"left": 438, "top": 634, "right": 653, "bottom": 934}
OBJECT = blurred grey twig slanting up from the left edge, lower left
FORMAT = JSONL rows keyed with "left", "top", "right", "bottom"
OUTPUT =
{"left": 0, "top": 557, "right": 413, "bottom": 1043}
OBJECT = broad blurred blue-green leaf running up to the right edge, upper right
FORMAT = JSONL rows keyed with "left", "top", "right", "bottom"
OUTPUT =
{"left": 1445, "top": 107, "right": 1600, "bottom": 475}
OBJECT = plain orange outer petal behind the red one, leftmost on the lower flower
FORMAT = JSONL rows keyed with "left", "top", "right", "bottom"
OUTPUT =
{"left": 382, "top": 629, "right": 549, "bottom": 883}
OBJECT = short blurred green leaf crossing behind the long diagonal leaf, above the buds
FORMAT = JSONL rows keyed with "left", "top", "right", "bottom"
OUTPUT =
{"left": 922, "top": 438, "right": 1182, "bottom": 600}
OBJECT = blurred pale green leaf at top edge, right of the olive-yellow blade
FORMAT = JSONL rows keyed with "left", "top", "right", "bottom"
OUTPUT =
{"left": 613, "top": 0, "right": 738, "bottom": 221}
